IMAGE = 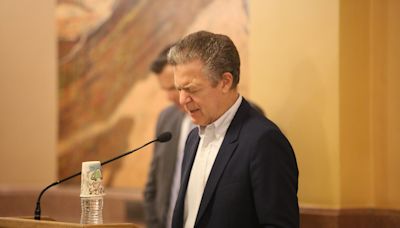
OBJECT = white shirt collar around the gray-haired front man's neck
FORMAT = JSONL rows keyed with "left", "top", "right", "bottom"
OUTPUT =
{"left": 198, "top": 95, "right": 243, "bottom": 138}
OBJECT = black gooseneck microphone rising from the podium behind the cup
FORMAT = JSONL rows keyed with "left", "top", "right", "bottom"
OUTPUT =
{"left": 35, "top": 131, "right": 172, "bottom": 220}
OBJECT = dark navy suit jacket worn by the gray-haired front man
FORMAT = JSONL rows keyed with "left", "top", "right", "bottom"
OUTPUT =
{"left": 172, "top": 99, "right": 299, "bottom": 228}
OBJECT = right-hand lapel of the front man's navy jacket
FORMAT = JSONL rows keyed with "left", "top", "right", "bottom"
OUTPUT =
{"left": 195, "top": 99, "right": 248, "bottom": 226}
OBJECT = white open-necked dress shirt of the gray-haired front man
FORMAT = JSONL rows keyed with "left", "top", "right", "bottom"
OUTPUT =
{"left": 184, "top": 96, "right": 242, "bottom": 228}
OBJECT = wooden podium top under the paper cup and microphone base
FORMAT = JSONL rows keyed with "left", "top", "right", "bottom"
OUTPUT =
{"left": 0, "top": 217, "right": 138, "bottom": 228}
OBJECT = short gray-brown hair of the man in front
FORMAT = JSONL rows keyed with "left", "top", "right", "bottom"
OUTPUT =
{"left": 168, "top": 31, "right": 240, "bottom": 88}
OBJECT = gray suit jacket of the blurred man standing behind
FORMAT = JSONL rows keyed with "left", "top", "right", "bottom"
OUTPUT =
{"left": 144, "top": 105, "right": 185, "bottom": 228}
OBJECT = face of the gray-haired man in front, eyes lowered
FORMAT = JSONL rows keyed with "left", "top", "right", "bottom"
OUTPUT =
{"left": 174, "top": 61, "right": 229, "bottom": 126}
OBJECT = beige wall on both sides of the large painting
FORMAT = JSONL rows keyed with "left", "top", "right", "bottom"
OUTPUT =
{"left": 0, "top": 0, "right": 400, "bottom": 211}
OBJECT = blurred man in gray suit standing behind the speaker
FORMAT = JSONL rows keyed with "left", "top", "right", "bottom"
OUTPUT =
{"left": 144, "top": 45, "right": 193, "bottom": 228}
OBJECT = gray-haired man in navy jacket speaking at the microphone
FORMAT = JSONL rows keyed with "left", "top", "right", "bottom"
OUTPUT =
{"left": 168, "top": 31, "right": 299, "bottom": 228}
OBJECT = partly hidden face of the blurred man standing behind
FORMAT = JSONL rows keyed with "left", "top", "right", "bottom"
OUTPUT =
{"left": 158, "top": 64, "right": 181, "bottom": 108}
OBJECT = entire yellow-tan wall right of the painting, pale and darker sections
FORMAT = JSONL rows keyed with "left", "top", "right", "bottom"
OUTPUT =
{"left": 249, "top": 0, "right": 400, "bottom": 208}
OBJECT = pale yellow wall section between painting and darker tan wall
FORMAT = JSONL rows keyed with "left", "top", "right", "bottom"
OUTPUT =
{"left": 250, "top": 0, "right": 340, "bottom": 206}
